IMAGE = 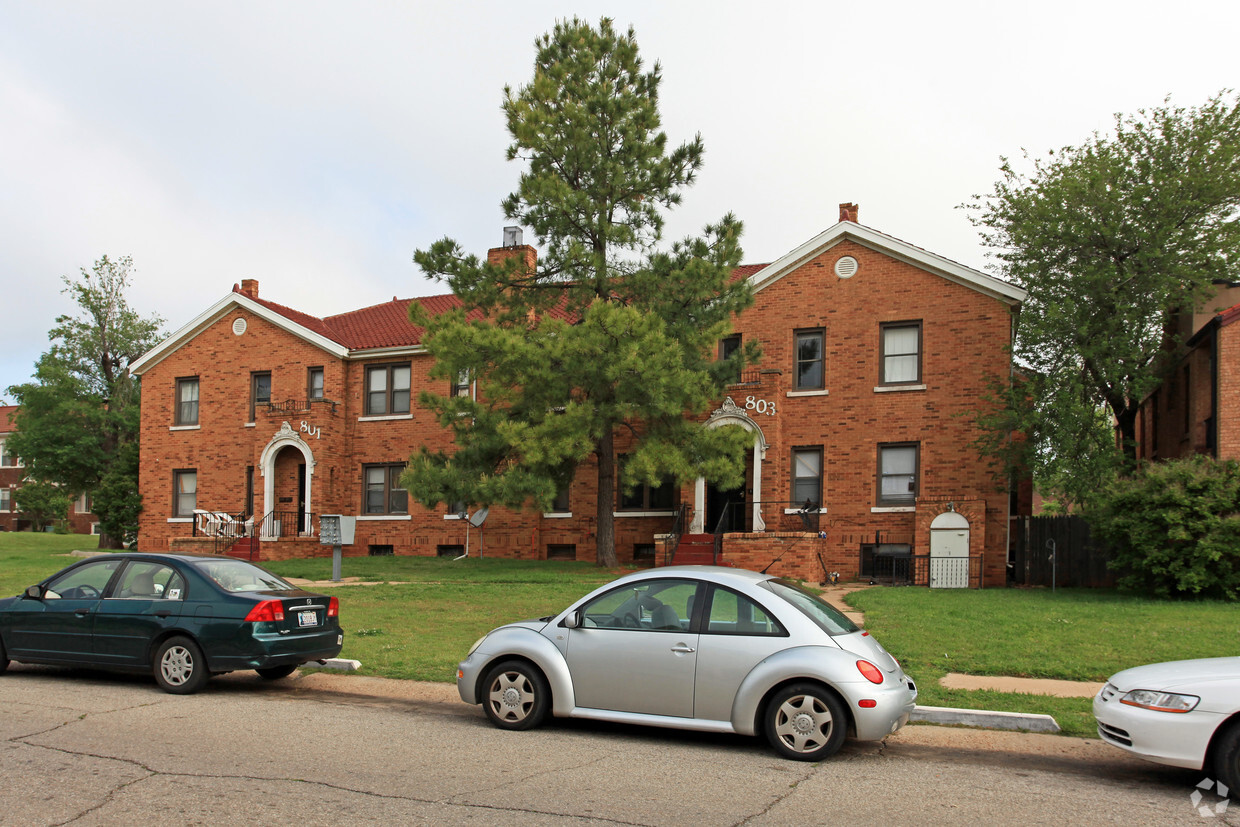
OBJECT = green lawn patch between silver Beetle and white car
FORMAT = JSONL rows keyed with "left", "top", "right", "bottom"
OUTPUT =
{"left": 847, "top": 588, "right": 1240, "bottom": 735}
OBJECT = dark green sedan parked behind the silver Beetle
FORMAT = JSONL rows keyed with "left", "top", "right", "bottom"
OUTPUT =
{"left": 0, "top": 553, "right": 345, "bottom": 694}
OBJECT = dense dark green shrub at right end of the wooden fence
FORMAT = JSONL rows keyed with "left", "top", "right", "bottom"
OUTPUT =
{"left": 1089, "top": 456, "right": 1240, "bottom": 600}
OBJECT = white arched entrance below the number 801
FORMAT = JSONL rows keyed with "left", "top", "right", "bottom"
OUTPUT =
{"left": 258, "top": 422, "right": 315, "bottom": 539}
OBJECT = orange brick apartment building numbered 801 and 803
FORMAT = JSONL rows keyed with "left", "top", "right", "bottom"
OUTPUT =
{"left": 134, "top": 205, "right": 1024, "bottom": 585}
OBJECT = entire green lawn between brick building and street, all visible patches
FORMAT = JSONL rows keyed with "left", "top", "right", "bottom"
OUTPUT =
{"left": 0, "top": 533, "right": 1240, "bottom": 735}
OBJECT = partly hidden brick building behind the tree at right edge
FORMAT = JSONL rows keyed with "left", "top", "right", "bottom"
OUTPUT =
{"left": 1137, "top": 284, "right": 1240, "bottom": 460}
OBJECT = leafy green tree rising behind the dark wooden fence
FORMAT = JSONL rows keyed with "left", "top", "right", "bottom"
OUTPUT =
{"left": 970, "top": 93, "right": 1240, "bottom": 505}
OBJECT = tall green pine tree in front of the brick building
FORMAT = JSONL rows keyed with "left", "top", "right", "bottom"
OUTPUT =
{"left": 403, "top": 19, "right": 756, "bottom": 565}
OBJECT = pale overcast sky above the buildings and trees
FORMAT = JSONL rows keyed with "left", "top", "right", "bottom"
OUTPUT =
{"left": 0, "top": 0, "right": 1240, "bottom": 400}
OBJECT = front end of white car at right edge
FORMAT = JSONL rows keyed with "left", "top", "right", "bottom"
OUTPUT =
{"left": 1094, "top": 657, "right": 1240, "bottom": 796}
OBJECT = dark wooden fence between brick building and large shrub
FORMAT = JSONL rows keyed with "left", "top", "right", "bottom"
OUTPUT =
{"left": 1012, "top": 517, "right": 1115, "bottom": 589}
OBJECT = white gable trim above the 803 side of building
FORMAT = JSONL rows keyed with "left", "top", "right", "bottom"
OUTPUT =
{"left": 749, "top": 221, "right": 1027, "bottom": 305}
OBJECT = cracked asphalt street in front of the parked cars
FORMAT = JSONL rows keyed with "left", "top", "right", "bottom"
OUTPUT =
{"left": 0, "top": 665, "right": 1240, "bottom": 827}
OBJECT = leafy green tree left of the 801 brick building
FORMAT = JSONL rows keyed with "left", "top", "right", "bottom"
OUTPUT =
{"left": 9, "top": 255, "right": 162, "bottom": 548}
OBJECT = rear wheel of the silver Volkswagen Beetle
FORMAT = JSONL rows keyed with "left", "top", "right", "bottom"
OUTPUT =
{"left": 765, "top": 683, "right": 848, "bottom": 761}
